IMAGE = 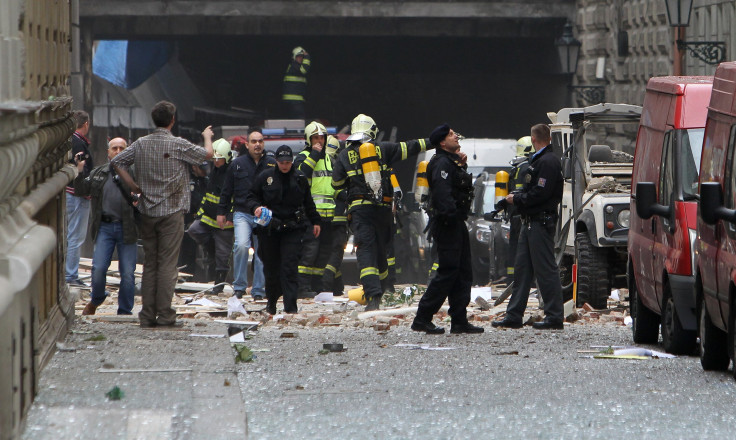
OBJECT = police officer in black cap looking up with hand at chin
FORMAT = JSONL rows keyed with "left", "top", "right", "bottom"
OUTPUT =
{"left": 411, "top": 124, "right": 483, "bottom": 334}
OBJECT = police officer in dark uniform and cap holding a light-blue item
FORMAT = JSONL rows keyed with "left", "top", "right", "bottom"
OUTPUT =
{"left": 246, "top": 145, "right": 320, "bottom": 315}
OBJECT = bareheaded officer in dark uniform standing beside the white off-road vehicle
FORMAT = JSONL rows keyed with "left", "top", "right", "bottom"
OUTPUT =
{"left": 492, "top": 124, "right": 564, "bottom": 330}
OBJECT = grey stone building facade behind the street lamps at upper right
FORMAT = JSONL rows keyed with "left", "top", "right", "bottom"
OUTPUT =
{"left": 571, "top": 0, "right": 736, "bottom": 106}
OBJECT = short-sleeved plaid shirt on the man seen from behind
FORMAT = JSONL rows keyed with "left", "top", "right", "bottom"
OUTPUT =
{"left": 111, "top": 128, "right": 207, "bottom": 217}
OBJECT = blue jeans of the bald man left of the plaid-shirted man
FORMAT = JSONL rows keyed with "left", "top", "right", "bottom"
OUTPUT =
{"left": 91, "top": 222, "right": 137, "bottom": 315}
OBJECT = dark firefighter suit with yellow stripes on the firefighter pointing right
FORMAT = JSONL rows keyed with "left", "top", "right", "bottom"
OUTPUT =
{"left": 332, "top": 139, "right": 434, "bottom": 310}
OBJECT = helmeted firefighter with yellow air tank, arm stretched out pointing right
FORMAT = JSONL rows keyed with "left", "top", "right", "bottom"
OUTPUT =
{"left": 332, "top": 114, "right": 433, "bottom": 310}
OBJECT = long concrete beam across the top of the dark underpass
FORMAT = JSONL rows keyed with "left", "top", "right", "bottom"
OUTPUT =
{"left": 80, "top": 0, "right": 574, "bottom": 39}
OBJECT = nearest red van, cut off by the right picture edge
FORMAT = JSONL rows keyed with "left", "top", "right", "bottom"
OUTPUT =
{"left": 695, "top": 62, "right": 736, "bottom": 377}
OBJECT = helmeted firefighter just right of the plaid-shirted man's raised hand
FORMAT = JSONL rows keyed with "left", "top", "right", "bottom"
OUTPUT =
{"left": 187, "top": 139, "right": 236, "bottom": 294}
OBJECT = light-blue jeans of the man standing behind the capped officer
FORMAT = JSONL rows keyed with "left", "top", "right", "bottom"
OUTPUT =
{"left": 233, "top": 211, "right": 266, "bottom": 297}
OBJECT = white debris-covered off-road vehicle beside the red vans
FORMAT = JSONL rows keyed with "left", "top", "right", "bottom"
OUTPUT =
{"left": 548, "top": 103, "right": 641, "bottom": 309}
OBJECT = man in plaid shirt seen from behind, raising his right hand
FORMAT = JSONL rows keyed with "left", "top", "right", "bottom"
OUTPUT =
{"left": 111, "top": 101, "right": 213, "bottom": 327}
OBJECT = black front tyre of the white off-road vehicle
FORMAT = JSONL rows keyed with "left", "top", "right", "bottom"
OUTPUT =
{"left": 575, "top": 232, "right": 611, "bottom": 309}
